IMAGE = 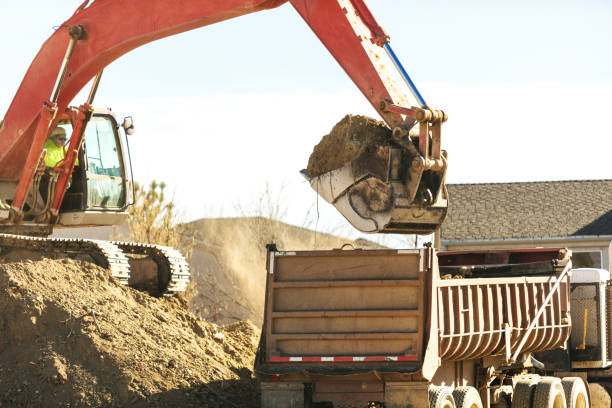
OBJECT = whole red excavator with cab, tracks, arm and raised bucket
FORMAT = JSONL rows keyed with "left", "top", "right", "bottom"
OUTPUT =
{"left": 0, "top": 0, "right": 448, "bottom": 295}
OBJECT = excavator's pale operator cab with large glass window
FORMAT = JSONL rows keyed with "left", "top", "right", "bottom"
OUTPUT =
{"left": 53, "top": 109, "right": 133, "bottom": 226}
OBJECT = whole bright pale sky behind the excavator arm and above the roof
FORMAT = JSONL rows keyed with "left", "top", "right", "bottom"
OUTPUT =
{"left": 0, "top": 0, "right": 612, "bottom": 245}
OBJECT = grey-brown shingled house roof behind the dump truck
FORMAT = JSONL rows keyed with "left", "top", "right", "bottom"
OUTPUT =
{"left": 441, "top": 180, "right": 612, "bottom": 240}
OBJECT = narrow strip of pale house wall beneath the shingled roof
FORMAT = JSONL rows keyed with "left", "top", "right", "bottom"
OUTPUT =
{"left": 440, "top": 236, "right": 612, "bottom": 273}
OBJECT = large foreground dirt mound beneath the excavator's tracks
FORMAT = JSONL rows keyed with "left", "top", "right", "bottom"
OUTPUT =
{"left": 0, "top": 259, "right": 259, "bottom": 407}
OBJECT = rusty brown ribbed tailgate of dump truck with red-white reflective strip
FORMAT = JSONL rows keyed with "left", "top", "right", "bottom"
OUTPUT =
{"left": 258, "top": 245, "right": 427, "bottom": 371}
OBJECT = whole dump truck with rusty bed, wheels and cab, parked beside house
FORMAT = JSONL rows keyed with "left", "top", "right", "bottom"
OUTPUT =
{"left": 255, "top": 245, "right": 612, "bottom": 408}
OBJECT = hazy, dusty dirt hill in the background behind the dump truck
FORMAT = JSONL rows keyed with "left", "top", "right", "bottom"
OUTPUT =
{"left": 186, "top": 217, "right": 381, "bottom": 325}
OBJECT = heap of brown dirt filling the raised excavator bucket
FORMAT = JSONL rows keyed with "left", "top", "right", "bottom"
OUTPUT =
{"left": 306, "top": 115, "right": 392, "bottom": 177}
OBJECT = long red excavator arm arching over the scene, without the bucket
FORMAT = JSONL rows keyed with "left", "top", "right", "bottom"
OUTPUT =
{"left": 0, "top": 0, "right": 445, "bottom": 231}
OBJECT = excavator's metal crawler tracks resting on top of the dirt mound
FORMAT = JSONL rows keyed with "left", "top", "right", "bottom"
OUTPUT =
{"left": 0, "top": 234, "right": 190, "bottom": 296}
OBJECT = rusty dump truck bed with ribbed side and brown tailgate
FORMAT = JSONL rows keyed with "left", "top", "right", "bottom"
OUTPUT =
{"left": 256, "top": 248, "right": 570, "bottom": 374}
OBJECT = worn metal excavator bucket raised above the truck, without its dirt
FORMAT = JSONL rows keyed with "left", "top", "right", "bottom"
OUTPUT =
{"left": 303, "top": 111, "right": 448, "bottom": 235}
